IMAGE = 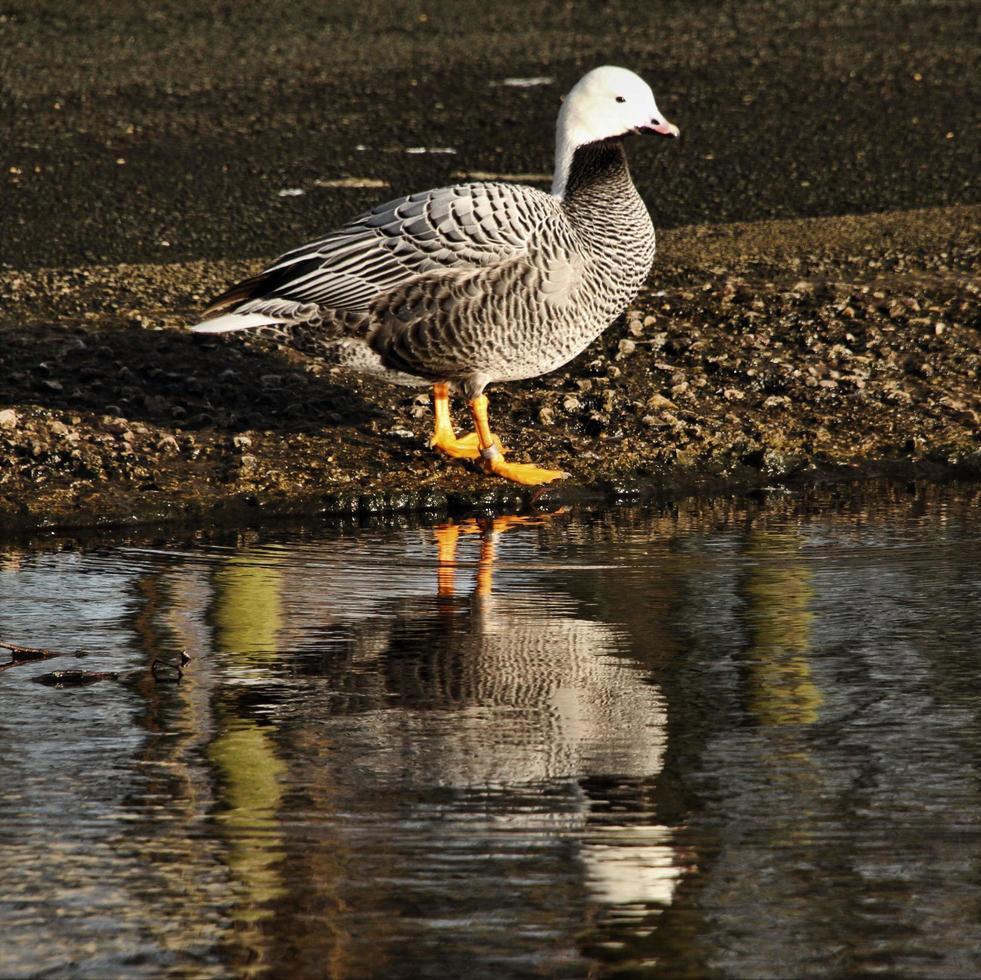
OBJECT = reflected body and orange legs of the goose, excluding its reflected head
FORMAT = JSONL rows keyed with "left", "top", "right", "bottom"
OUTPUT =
{"left": 353, "top": 517, "right": 665, "bottom": 786}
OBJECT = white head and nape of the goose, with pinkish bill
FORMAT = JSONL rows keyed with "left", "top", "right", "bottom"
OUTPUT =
{"left": 552, "top": 65, "right": 680, "bottom": 197}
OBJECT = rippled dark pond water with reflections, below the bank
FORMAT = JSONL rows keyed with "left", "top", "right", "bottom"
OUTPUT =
{"left": 0, "top": 486, "right": 981, "bottom": 978}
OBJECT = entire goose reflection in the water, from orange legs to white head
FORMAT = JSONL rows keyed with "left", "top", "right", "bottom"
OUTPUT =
{"left": 320, "top": 517, "right": 681, "bottom": 924}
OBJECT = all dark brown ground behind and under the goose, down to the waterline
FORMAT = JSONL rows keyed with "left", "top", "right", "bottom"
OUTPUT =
{"left": 0, "top": 0, "right": 981, "bottom": 529}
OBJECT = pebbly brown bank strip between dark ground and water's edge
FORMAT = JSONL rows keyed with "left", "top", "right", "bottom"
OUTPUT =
{"left": 0, "top": 206, "right": 981, "bottom": 530}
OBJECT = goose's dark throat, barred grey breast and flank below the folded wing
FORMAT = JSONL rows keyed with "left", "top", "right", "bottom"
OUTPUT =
{"left": 368, "top": 141, "right": 654, "bottom": 397}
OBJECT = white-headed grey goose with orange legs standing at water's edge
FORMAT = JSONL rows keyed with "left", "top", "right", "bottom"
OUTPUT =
{"left": 191, "top": 65, "right": 679, "bottom": 486}
